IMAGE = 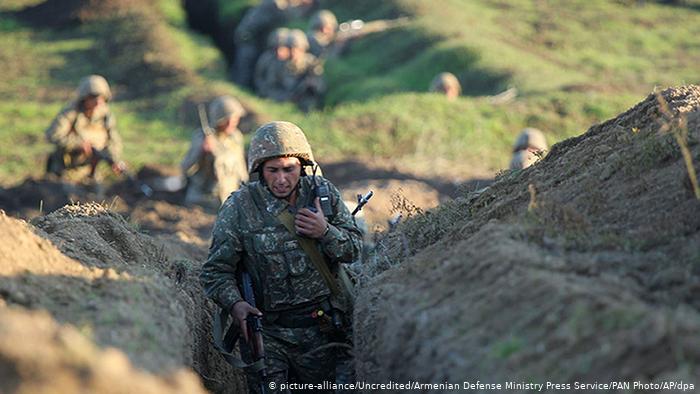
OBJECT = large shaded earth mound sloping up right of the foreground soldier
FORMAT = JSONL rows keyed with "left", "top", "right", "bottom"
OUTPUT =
{"left": 355, "top": 86, "right": 700, "bottom": 384}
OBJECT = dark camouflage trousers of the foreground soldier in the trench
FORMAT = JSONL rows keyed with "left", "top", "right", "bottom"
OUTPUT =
{"left": 241, "top": 324, "right": 355, "bottom": 394}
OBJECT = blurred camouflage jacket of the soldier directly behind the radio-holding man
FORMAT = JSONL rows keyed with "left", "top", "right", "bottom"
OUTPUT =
{"left": 180, "top": 128, "right": 248, "bottom": 190}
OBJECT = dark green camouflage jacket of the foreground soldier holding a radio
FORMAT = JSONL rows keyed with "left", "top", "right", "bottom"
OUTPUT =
{"left": 200, "top": 176, "right": 362, "bottom": 312}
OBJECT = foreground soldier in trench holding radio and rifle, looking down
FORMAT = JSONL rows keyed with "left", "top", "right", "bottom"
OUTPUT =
{"left": 200, "top": 122, "right": 362, "bottom": 393}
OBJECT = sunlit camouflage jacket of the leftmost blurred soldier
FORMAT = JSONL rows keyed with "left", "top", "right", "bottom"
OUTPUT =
{"left": 45, "top": 104, "right": 122, "bottom": 161}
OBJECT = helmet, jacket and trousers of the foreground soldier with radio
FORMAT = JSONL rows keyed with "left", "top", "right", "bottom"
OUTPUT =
{"left": 200, "top": 122, "right": 362, "bottom": 392}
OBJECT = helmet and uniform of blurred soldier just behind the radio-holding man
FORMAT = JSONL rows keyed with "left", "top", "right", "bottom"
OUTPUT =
{"left": 180, "top": 96, "right": 248, "bottom": 206}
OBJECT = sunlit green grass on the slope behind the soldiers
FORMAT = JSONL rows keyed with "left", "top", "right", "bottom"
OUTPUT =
{"left": 0, "top": 0, "right": 700, "bottom": 184}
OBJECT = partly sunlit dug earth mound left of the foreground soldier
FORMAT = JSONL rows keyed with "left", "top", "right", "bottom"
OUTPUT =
{"left": 0, "top": 203, "right": 244, "bottom": 392}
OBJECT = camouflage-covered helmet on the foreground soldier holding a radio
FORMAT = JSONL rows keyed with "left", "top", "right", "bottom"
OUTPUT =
{"left": 248, "top": 121, "right": 314, "bottom": 174}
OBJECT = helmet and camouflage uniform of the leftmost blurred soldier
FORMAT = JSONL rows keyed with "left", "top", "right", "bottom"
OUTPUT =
{"left": 45, "top": 75, "right": 122, "bottom": 177}
